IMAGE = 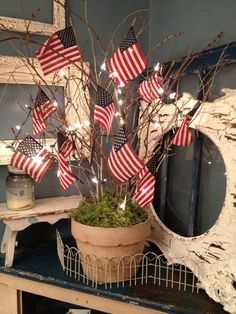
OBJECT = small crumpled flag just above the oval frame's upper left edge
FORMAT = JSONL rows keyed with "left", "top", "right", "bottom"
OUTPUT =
{"left": 138, "top": 72, "right": 164, "bottom": 102}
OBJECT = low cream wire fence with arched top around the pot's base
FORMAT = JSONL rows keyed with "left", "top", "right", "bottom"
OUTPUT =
{"left": 57, "top": 234, "right": 199, "bottom": 293}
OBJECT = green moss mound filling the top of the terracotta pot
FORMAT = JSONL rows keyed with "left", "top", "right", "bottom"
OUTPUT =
{"left": 70, "top": 192, "right": 148, "bottom": 228}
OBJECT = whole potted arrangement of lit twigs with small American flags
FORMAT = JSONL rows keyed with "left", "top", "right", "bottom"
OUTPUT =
{"left": 0, "top": 4, "right": 184, "bottom": 282}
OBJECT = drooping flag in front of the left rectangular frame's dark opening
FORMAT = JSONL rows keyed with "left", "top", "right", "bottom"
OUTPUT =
{"left": 33, "top": 88, "right": 57, "bottom": 136}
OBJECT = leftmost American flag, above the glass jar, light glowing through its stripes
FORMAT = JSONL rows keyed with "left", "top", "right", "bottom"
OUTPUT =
{"left": 10, "top": 135, "right": 52, "bottom": 182}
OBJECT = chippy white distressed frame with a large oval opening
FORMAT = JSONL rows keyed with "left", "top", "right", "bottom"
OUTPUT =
{"left": 141, "top": 90, "right": 236, "bottom": 313}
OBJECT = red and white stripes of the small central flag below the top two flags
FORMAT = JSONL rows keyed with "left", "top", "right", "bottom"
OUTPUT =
{"left": 94, "top": 103, "right": 115, "bottom": 135}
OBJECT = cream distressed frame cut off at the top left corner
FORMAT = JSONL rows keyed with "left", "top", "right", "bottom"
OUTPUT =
{"left": 0, "top": 0, "right": 65, "bottom": 36}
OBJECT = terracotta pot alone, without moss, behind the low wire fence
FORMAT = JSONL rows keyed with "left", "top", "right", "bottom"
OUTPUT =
{"left": 71, "top": 218, "right": 150, "bottom": 283}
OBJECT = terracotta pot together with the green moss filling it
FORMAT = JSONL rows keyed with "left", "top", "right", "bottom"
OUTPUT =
{"left": 70, "top": 192, "right": 150, "bottom": 282}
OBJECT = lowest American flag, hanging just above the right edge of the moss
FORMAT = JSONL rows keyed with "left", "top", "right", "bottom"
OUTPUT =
{"left": 134, "top": 154, "right": 159, "bottom": 208}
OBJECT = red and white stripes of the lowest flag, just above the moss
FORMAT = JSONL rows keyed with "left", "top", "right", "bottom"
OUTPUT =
{"left": 134, "top": 166, "right": 155, "bottom": 208}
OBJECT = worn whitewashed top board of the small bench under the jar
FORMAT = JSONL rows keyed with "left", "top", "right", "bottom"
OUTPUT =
{"left": 0, "top": 195, "right": 81, "bottom": 220}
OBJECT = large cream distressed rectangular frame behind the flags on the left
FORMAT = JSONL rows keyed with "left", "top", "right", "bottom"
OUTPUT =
{"left": 0, "top": 56, "right": 90, "bottom": 165}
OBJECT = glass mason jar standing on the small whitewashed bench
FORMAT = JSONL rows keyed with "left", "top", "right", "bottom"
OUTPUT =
{"left": 6, "top": 166, "right": 35, "bottom": 210}
